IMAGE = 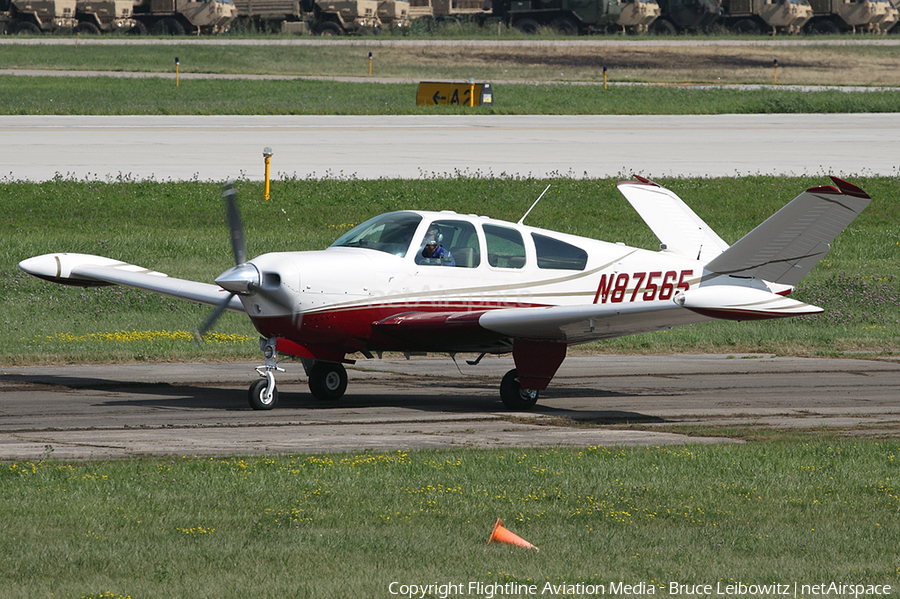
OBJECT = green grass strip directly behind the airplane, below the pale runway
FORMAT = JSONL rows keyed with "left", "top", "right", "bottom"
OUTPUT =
{"left": 0, "top": 176, "right": 900, "bottom": 364}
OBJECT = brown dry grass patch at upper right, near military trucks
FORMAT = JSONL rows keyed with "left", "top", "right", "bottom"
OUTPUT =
{"left": 384, "top": 42, "right": 900, "bottom": 86}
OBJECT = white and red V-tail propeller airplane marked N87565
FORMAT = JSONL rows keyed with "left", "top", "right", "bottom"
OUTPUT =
{"left": 19, "top": 177, "right": 870, "bottom": 410}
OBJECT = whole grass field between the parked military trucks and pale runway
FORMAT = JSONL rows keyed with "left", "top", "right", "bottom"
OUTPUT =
{"left": 0, "top": 37, "right": 900, "bottom": 115}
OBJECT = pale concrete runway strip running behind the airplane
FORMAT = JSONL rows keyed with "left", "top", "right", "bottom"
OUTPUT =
{"left": 0, "top": 113, "right": 900, "bottom": 181}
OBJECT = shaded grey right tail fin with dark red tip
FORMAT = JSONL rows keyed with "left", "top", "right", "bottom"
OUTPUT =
{"left": 706, "top": 177, "right": 871, "bottom": 286}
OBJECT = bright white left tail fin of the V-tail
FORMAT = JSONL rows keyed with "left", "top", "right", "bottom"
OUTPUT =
{"left": 617, "top": 177, "right": 728, "bottom": 260}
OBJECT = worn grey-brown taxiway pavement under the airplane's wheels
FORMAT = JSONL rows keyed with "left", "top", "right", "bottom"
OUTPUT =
{"left": 0, "top": 355, "right": 900, "bottom": 459}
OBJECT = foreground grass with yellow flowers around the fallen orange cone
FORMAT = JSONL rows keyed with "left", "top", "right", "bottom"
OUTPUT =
{"left": 0, "top": 435, "right": 900, "bottom": 599}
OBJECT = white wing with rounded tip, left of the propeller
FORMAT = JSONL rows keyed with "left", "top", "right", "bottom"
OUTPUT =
{"left": 19, "top": 254, "right": 245, "bottom": 312}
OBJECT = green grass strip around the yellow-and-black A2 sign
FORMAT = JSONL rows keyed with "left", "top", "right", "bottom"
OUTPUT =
{"left": 0, "top": 76, "right": 900, "bottom": 115}
